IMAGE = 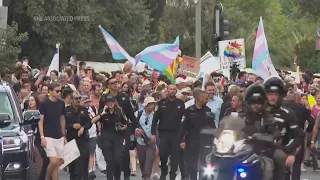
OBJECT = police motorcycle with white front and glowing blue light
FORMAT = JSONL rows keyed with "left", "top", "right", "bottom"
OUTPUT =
{"left": 200, "top": 116, "right": 274, "bottom": 180}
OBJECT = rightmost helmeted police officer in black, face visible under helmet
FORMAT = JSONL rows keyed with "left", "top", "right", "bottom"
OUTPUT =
{"left": 264, "top": 77, "right": 303, "bottom": 179}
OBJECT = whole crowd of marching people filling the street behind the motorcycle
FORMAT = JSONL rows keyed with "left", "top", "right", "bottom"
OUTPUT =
{"left": 2, "top": 54, "right": 320, "bottom": 180}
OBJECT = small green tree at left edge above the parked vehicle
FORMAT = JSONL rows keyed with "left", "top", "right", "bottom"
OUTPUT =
{"left": 0, "top": 23, "right": 28, "bottom": 68}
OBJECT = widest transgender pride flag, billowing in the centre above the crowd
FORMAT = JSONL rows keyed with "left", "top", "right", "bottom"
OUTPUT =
{"left": 135, "top": 37, "right": 180, "bottom": 71}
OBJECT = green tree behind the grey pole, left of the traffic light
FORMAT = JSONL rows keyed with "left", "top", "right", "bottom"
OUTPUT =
{"left": 159, "top": 0, "right": 220, "bottom": 56}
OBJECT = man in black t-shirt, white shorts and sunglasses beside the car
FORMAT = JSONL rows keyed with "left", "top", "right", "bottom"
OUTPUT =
{"left": 39, "top": 82, "right": 67, "bottom": 180}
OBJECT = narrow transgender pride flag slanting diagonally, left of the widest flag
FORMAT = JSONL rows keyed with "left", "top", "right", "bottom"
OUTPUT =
{"left": 99, "top": 25, "right": 136, "bottom": 64}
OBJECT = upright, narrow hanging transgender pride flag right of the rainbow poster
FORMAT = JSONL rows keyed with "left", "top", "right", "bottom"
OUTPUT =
{"left": 252, "top": 17, "right": 279, "bottom": 79}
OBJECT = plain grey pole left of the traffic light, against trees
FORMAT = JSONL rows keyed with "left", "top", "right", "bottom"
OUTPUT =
{"left": 194, "top": 0, "right": 202, "bottom": 59}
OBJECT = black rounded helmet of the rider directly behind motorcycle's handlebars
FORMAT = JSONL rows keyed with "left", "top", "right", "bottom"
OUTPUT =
{"left": 245, "top": 84, "right": 267, "bottom": 104}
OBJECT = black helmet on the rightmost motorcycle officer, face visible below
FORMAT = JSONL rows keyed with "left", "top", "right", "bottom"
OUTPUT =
{"left": 263, "top": 77, "right": 286, "bottom": 95}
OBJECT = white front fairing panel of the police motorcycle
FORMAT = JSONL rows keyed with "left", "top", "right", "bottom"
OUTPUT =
{"left": 216, "top": 131, "right": 235, "bottom": 153}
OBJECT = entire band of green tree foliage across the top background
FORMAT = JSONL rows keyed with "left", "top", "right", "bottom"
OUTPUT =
{"left": 2, "top": 0, "right": 320, "bottom": 71}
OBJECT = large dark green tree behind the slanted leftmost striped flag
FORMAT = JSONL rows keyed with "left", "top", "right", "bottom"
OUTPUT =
{"left": 11, "top": 0, "right": 150, "bottom": 65}
